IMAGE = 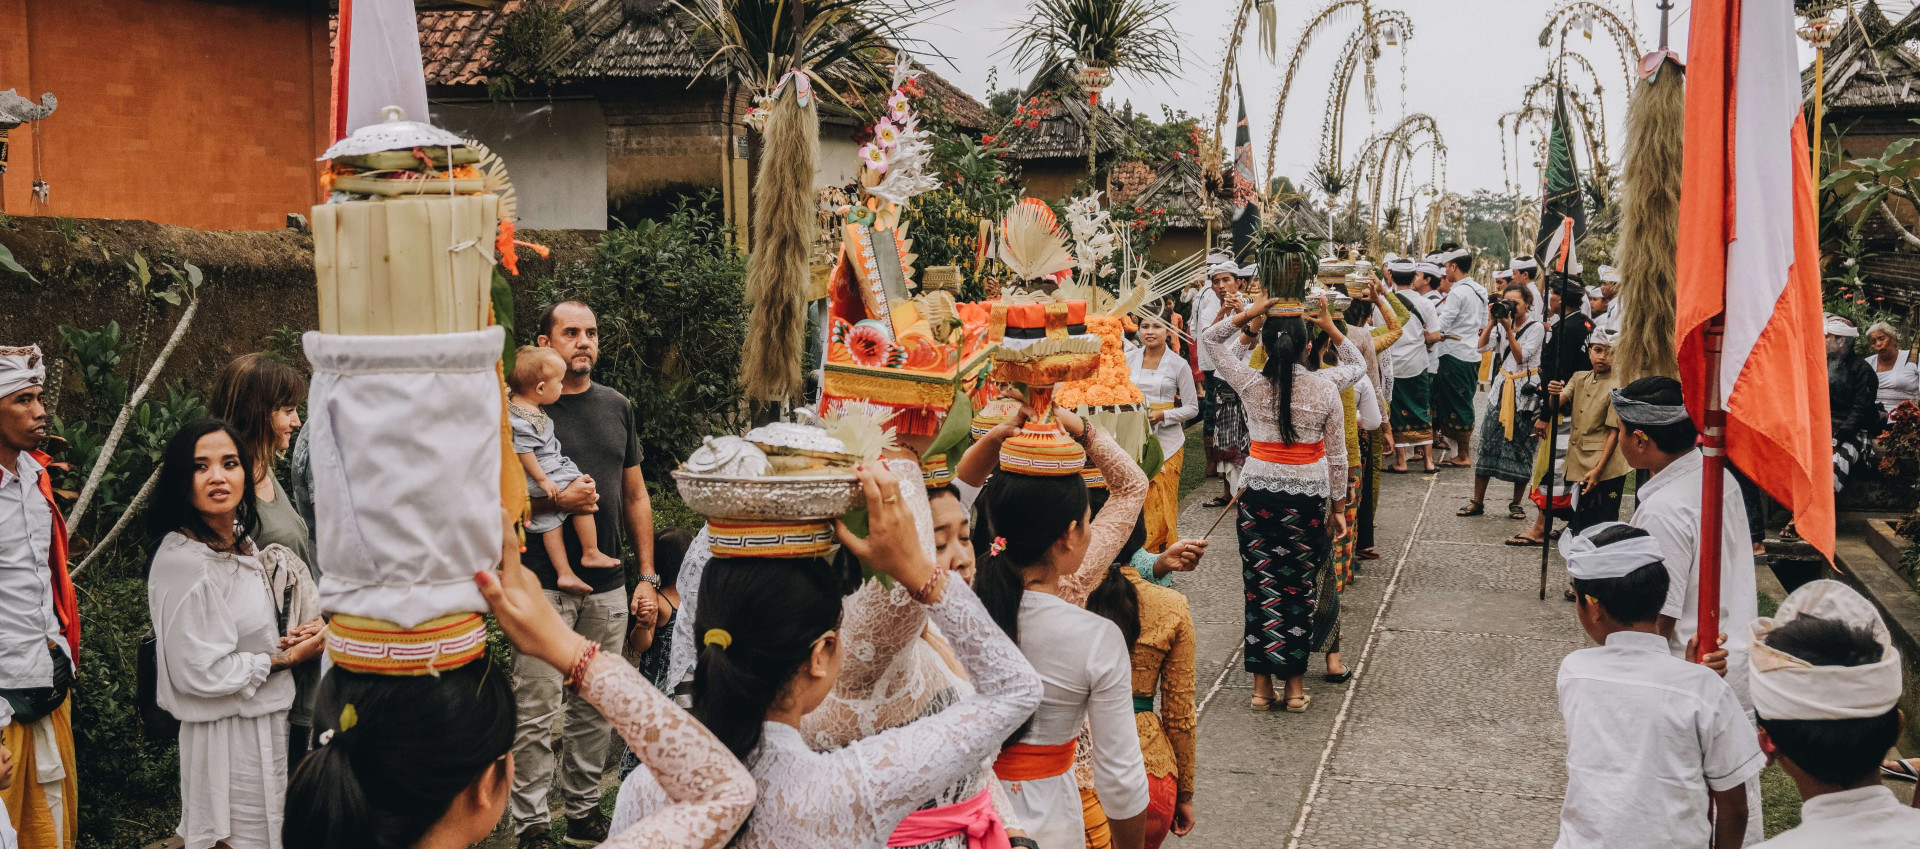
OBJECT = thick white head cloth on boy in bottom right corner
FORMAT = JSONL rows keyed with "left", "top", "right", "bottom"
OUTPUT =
{"left": 1747, "top": 580, "right": 1901, "bottom": 720}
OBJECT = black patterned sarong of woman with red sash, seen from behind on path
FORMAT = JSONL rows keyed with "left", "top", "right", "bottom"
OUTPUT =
{"left": 1238, "top": 488, "right": 1338, "bottom": 678}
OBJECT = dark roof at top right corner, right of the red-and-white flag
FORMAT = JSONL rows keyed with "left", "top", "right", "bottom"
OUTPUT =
{"left": 1801, "top": 0, "right": 1920, "bottom": 117}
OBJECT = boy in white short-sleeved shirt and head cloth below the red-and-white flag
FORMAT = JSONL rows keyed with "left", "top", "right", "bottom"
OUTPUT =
{"left": 1553, "top": 522, "right": 1766, "bottom": 849}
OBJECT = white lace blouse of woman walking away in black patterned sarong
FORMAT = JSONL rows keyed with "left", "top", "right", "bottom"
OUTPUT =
{"left": 1200, "top": 321, "right": 1367, "bottom": 497}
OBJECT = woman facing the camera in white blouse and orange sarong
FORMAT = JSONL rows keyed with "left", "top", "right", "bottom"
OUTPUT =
{"left": 1127, "top": 317, "right": 1200, "bottom": 553}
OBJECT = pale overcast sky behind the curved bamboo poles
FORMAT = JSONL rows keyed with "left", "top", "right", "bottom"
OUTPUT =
{"left": 912, "top": 0, "right": 1843, "bottom": 192}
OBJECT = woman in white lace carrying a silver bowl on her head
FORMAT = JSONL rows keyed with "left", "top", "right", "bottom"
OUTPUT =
{"left": 612, "top": 463, "right": 1041, "bottom": 849}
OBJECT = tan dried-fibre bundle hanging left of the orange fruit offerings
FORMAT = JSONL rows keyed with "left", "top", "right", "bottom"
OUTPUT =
{"left": 741, "top": 84, "right": 820, "bottom": 401}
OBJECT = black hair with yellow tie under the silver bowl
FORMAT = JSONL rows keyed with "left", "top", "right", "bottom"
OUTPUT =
{"left": 693, "top": 557, "right": 840, "bottom": 761}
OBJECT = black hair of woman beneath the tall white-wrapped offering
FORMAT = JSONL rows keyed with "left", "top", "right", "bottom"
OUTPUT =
{"left": 280, "top": 659, "right": 516, "bottom": 849}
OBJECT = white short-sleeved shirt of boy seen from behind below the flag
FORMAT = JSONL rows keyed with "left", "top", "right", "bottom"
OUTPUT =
{"left": 1553, "top": 632, "right": 1766, "bottom": 849}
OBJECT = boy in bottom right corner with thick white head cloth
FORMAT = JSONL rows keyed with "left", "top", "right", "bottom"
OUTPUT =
{"left": 1749, "top": 580, "right": 1920, "bottom": 849}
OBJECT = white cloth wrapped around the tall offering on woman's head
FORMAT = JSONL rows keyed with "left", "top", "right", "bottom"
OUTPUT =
{"left": 303, "top": 327, "right": 505, "bottom": 628}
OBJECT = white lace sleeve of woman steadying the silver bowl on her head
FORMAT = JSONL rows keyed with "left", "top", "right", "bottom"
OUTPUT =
{"left": 831, "top": 580, "right": 1041, "bottom": 837}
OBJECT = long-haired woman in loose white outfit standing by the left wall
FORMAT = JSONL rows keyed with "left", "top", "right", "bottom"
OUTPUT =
{"left": 148, "top": 419, "right": 324, "bottom": 849}
